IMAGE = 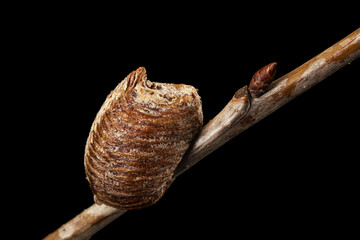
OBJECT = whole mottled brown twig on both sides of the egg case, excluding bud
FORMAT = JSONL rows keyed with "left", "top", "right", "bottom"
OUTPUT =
{"left": 44, "top": 28, "right": 360, "bottom": 240}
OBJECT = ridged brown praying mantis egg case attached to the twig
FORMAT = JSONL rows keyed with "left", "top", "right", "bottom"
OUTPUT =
{"left": 84, "top": 67, "right": 203, "bottom": 209}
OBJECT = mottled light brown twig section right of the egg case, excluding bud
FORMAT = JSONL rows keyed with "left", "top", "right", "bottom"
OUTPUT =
{"left": 176, "top": 28, "right": 360, "bottom": 173}
